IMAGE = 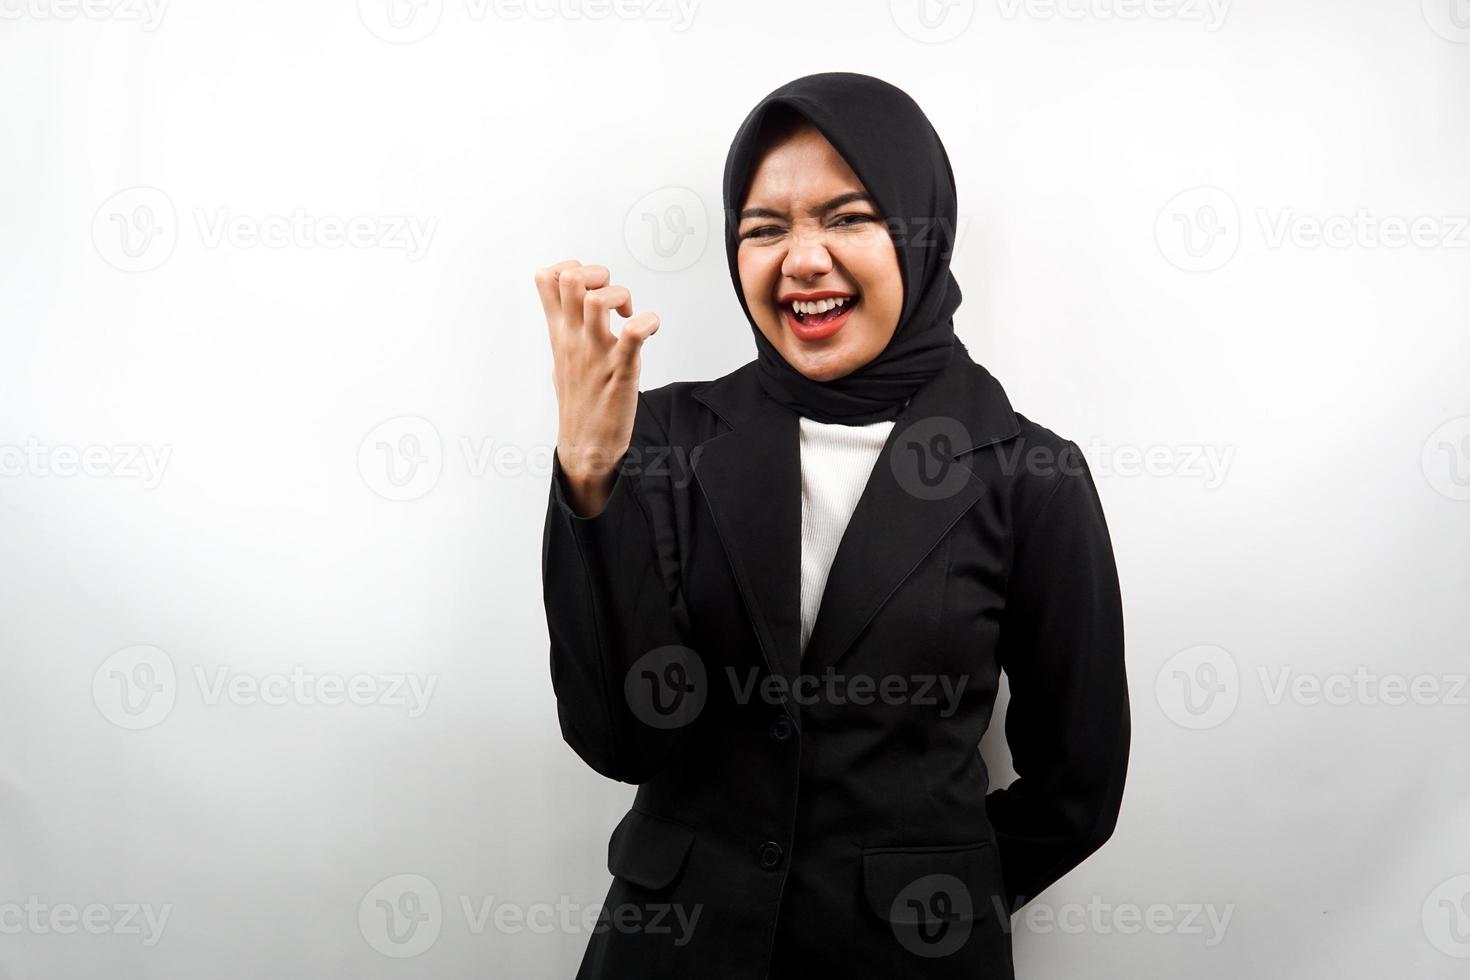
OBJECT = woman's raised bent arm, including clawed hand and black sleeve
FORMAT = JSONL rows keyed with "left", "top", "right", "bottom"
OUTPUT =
{"left": 535, "top": 260, "right": 682, "bottom": 783}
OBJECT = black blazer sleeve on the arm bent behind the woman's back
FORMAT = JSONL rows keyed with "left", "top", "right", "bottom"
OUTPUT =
{"left": 986, "top": 441, "right": 1130, "bottom": 912}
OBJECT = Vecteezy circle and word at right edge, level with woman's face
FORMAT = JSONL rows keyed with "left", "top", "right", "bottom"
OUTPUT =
{"left": 1154, "top": 187, "right": 1470, "bottom": 272}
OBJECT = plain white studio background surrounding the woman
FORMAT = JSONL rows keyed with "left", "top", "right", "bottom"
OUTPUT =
{"left": 0, "top": 0, "right": 1470, "bottom": 980}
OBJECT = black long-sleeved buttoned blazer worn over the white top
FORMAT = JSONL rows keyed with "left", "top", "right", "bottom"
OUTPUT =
{"left": 542, "top": 351, "right": 1130, "bottom": 980}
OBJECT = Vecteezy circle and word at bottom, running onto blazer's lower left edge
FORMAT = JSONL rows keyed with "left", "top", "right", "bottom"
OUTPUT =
{"left": 357, "top": 874, "right": 704, "bottom": 959}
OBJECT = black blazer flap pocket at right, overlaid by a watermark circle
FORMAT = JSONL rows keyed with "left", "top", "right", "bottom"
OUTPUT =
{"left": 863, "top": 840, "right": 1004, "bottom": 929}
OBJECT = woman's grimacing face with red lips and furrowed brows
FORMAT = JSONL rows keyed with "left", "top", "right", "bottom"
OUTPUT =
{"left": 736, "top": 123, "right": 904, "bottom": 381}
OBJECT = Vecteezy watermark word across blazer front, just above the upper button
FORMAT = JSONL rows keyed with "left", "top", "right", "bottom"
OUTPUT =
{"left": 725, "top": 667, "right": 970, "bottom": 718}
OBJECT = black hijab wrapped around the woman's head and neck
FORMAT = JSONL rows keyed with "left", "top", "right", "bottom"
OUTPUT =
{"left": 725, "top": 72, "right": 964, "bottom": 425}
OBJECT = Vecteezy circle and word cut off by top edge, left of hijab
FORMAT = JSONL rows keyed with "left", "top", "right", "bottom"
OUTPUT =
{"left": 357, "top": 0, "right": 700, "bottom": 44}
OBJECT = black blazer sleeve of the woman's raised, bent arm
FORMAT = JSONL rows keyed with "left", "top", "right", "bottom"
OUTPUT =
{"left": 541, "top": 394, "right": 686, "bottom": 783}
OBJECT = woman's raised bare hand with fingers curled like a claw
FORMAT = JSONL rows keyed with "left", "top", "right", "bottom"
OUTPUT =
{"left": 537, "top": 259, "right": 659, "bottom": 516}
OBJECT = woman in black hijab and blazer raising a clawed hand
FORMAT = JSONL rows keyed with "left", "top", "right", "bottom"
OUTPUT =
{"left": 537, "top": 72, "right": 1129, "bottom": 980}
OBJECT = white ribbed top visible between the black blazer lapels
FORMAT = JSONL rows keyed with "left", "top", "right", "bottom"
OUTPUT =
{"left": 801, "top": 417, "right": 894, "bottom": 652}
